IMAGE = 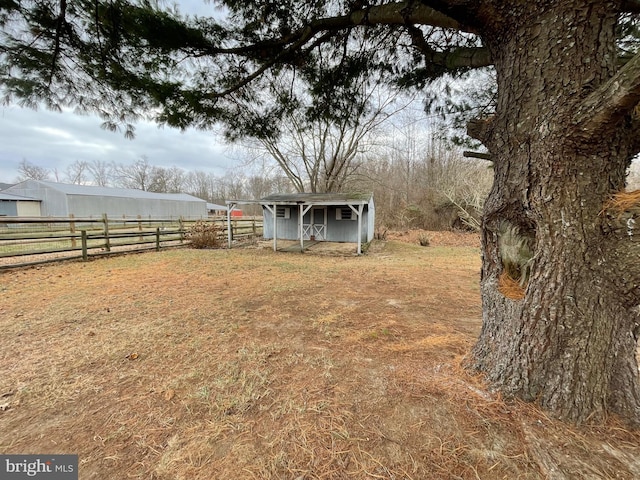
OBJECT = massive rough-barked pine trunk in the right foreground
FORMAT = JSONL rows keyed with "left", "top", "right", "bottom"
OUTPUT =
{"left": 470, "top": 0, "right": 640, "bottom": 422}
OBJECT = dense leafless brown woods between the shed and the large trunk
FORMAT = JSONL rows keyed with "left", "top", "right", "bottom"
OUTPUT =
{"left": 352, "top": 116, "right": 493, "bottom": 230}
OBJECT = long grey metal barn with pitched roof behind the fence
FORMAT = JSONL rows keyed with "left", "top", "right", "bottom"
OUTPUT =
{"left": 2, "top": 180, "right": 207, "bottom": 219}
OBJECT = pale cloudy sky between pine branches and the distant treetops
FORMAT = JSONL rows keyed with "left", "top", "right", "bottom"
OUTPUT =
{"left": 0, "top": 106, "right": 238, "bottom": 183}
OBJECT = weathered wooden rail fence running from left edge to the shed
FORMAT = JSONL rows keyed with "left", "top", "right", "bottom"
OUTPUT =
{"left": 0, "top": 215, "right": 262, "bottom": 269}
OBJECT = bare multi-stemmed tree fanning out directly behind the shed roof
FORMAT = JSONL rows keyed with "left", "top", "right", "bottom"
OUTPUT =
{"left": 242, "top": 72, "right": 411, "bottom": 192}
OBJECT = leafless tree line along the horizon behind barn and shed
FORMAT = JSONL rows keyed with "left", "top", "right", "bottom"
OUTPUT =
{"left": 16, "top": 127, "right": 493, "bottom": 230}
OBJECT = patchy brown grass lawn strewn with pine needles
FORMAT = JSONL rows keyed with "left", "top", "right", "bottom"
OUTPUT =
{"left": 0, "top": 232, "right": 639, "bottom": 480}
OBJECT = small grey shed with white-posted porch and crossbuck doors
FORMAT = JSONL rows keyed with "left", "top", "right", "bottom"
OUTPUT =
{"left": 226, "top": 193, "right": 375, "bottom": 254}
